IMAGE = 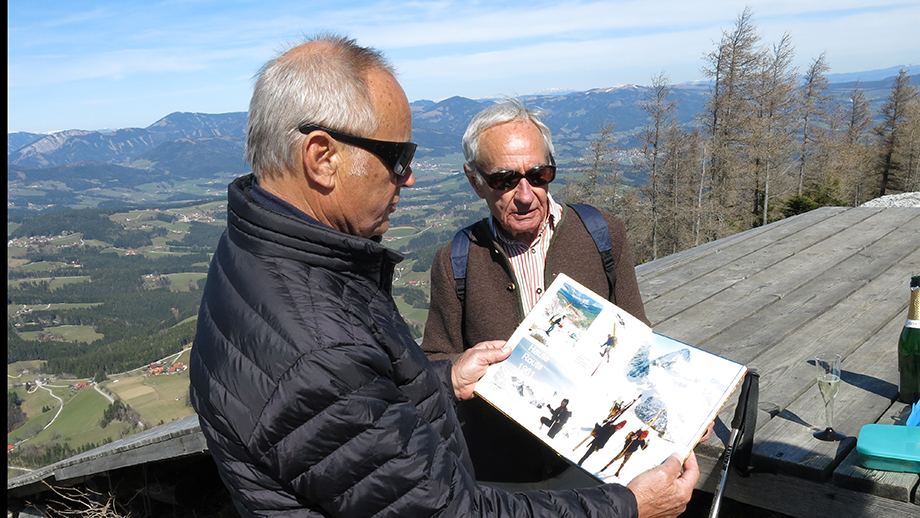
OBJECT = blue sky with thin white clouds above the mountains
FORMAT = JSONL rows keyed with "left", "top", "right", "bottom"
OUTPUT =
{"left": 7, "top": 0, "right": 920, "bottom": 132}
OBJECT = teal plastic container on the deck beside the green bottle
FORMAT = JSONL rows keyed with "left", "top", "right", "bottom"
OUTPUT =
{"left": 856, "top": 424, "right": 920, "bottom": 473}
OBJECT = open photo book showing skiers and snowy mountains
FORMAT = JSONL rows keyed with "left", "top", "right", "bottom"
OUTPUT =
{"left": 476, "top": 274, "right": 747, "bottom": 484}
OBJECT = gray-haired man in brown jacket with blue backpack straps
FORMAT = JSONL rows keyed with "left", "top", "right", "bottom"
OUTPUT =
{"left": 422, "top": 99, "right": 648, "bottom": 489}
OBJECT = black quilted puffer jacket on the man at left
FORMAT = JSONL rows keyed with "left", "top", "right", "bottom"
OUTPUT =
{"left": 191, "top": 176, "right": 636, "bottom": 518}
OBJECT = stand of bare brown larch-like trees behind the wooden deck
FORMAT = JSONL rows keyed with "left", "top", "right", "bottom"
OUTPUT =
{"left": 558, "top": 8, "right": 920, "bottom": 263}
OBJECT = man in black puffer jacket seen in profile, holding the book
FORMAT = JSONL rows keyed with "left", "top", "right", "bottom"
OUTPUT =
{"left": 191, "top": 36, "right": 699, "bottom": 518}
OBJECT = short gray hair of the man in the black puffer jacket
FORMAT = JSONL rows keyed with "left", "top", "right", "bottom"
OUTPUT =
{"left": 246, "top": 34, "right": 395, "bottom": 177}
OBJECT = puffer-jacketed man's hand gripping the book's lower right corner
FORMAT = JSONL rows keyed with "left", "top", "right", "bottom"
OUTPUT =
{"left": 626, "top": 452, "right": 700, "bottom": 518}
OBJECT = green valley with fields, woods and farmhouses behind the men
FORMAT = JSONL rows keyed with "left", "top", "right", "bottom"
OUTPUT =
{"left": 7, "top": 178, "right": 485, "bottom": 475}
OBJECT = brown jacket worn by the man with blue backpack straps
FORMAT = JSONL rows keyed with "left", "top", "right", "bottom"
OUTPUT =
{"left": 422, "top": 207, "right": 649, "bottom": 488}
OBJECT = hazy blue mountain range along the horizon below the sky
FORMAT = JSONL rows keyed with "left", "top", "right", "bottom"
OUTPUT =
{"left": 7, "top": 67, "right": 920, "bottom": 217}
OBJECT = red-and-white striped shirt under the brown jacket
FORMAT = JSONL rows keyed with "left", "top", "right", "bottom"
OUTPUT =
{"left": 489, "top": 197, "right": 562, "bottom": 315}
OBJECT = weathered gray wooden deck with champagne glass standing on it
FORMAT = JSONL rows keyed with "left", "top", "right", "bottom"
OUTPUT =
{"left": 637, "top": 208, "right": 920, "bottom": 518}
